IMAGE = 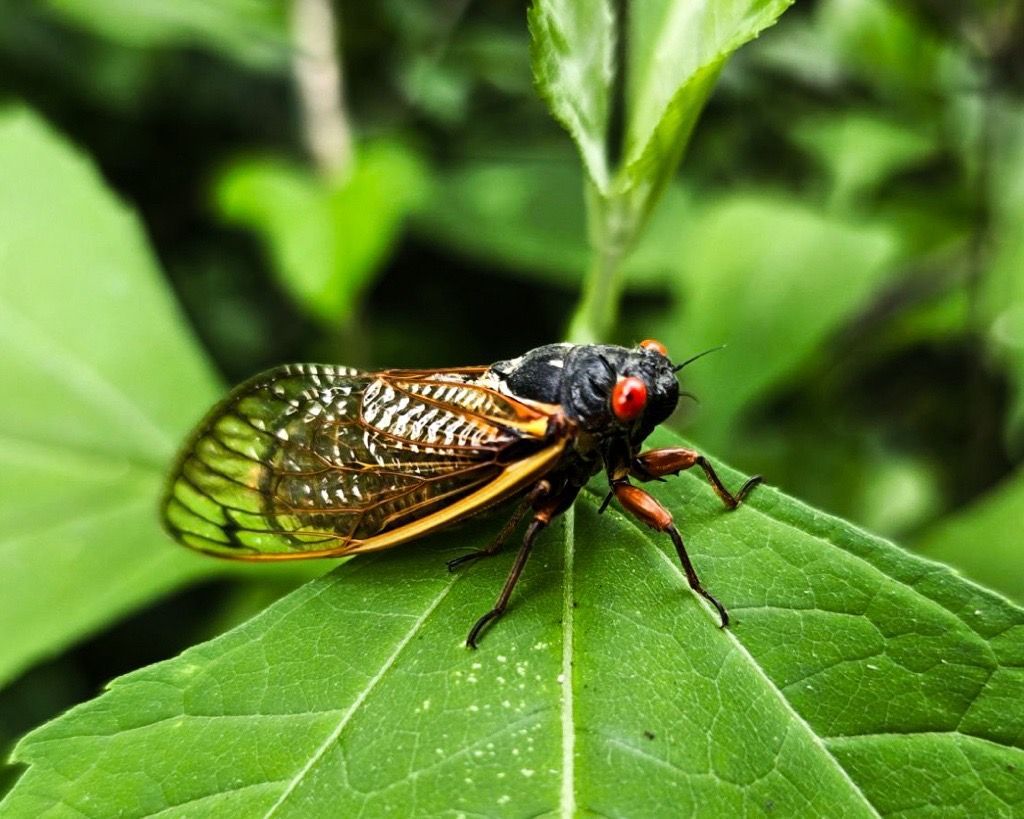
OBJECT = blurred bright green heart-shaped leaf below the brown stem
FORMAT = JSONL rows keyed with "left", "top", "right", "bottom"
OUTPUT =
{"left": 216, "top": 141, "right": 425, "bottom": 325}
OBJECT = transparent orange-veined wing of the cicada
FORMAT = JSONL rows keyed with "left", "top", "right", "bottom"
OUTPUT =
{"left": 164, "top": 364, "right": 565, "bottom": 560}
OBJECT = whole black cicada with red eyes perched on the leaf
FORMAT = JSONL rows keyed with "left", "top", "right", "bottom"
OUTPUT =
{"left": 163, "top": 339, "right": 760, "bottom": 648}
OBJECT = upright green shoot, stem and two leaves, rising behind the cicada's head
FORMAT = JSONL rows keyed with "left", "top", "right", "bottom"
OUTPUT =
{"left": 529, "top": 0, "right": 793, "bottom": 341}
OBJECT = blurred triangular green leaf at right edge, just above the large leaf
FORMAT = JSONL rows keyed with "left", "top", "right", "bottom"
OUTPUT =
{"left": 914, "top": 472, "right": 1024, "bottom": 602}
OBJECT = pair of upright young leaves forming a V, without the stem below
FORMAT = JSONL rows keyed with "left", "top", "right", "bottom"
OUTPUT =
{"left": 529, "top": 0, "right": 793, "bottom": 201}
